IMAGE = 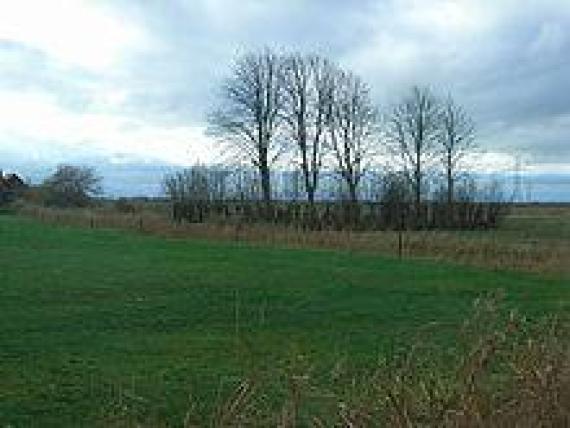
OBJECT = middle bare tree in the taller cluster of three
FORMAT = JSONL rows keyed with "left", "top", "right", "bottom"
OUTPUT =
{"left": 283, "top": 54, "right": 333, "bottom": 204}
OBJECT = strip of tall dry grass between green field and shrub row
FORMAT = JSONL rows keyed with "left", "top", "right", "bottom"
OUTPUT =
{"left": 15, "top": 205, "right": 570, "bottom": 274}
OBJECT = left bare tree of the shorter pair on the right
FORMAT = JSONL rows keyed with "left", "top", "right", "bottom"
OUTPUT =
{"left": 386, "top": 86, "right": 441, "bottom": 214}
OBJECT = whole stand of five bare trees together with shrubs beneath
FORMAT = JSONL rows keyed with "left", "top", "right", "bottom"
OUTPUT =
{"left": 164, "top": 49, "right": 502, "bottom": 228}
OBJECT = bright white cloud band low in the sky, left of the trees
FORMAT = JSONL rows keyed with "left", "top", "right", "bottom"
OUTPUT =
{"left": 0, "top": 91, "right": 215, "bottom": 165}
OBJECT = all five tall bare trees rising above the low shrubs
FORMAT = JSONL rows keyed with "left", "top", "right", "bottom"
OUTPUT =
{"left": 209, "top": 49, "right": 475, "bottom": 213}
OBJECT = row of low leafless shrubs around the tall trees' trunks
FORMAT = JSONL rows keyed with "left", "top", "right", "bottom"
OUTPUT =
{"left": 164, "top": 165, "right": 506, "bottom": 230}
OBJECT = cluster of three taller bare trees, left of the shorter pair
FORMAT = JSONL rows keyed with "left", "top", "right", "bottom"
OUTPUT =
{"left": 210, "top": 50, "right": 380, "bottom": 204}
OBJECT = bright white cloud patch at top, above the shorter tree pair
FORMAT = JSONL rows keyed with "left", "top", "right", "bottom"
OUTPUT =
{"left": 343, "top": 0, "right": 492, "bottom": 103}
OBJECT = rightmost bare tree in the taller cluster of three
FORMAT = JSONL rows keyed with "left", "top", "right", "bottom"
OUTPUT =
{"left": 327, "top": 70, "right": 379, "bottom": 203}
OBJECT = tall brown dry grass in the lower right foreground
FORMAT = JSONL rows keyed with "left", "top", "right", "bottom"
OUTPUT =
{"left": 95, "top": 295, "right": 570, "bottom": 428}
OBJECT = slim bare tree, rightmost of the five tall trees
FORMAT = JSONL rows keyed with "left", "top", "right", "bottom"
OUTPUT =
{"left": 434, "top": 96, "right": 476, "bottom": 207}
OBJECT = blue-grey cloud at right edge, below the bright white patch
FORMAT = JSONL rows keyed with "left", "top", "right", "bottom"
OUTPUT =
{"left": 332, "top": 0, "right": 570, "bottom": 163}
